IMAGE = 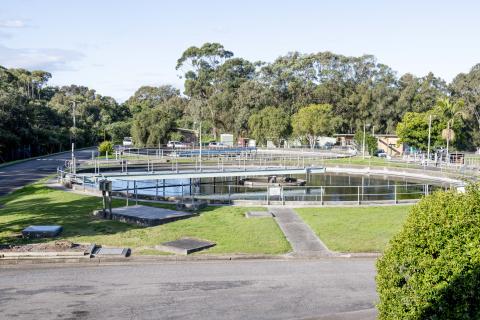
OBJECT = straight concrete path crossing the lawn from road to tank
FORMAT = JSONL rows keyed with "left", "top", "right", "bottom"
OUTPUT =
{"left": 270, "top": 208, "right": 335, "bottom": 257}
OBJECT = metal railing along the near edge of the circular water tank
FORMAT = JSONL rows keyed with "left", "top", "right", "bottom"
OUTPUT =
{"left": 59, "top": 171, "right": 455, "bottom": 206}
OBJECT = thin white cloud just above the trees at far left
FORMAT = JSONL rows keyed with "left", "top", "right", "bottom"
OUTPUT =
{"left": 0, "top": 44, "right": 84, "bottom": 72}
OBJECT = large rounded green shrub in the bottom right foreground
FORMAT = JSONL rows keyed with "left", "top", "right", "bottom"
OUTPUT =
{"left": 376, "top": 185, "right": 480, "bottom": 320}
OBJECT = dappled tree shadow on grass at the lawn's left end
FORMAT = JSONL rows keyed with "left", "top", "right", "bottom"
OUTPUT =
{"left": 0, "top": 184, "right": 146, "bottom": 244}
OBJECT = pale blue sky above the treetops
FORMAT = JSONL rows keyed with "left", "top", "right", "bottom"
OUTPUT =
{"left": 0, "top": 0, "right": 480, "bottom": 101}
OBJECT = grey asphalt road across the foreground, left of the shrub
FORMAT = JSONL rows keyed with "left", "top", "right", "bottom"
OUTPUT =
{"left": 0, "top": 259, "right": 376, "bottom": 320}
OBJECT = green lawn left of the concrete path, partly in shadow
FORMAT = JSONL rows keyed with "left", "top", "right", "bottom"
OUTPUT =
{"left": 0, "top": 184, "right": 290, "bottom": 254}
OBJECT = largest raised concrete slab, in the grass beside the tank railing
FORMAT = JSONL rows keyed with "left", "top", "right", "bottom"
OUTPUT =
{"left": 106, "top": 205, "right": 195, "bottom": 227}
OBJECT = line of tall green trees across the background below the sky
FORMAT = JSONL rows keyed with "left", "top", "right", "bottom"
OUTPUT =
{"left": 0, "top": 43, "right": 480, "bottom": 161}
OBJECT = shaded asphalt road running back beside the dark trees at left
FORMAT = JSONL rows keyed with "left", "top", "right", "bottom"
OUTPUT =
{"left": 0, "top": 149, "right": 94, "bottom": 196}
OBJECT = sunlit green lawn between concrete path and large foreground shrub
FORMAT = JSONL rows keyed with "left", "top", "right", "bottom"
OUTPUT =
{"left": 296, "top": 205, "right": 410, "bottom": 252}
